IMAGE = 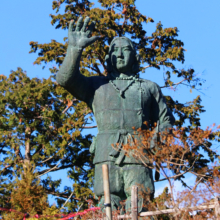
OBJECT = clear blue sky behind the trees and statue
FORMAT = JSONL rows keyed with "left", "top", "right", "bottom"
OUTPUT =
{"left": 0, "top": 0, "right": 220, "bottom": 201}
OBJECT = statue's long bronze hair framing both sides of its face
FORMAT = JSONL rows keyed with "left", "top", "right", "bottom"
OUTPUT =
{"left": 105, "top": 37, "right": 139, "bottom": 74}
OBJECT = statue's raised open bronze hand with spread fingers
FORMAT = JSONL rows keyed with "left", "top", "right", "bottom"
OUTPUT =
{"left": 68, "top": 17, "right": 99, "bottom": 49}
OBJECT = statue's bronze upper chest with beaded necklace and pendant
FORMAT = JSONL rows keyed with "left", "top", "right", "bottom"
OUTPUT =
{"left": 92, "top": 80, "right": 150, "bottom": 113}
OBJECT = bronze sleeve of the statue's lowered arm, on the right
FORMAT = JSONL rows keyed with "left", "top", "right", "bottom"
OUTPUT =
{"left": 151, "top": 83, "right": 175, "bottom": 131}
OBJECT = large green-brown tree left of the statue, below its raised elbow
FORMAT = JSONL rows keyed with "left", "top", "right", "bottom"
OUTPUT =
{"left": 0, "top": 68, "right": 93, "bottom": 215}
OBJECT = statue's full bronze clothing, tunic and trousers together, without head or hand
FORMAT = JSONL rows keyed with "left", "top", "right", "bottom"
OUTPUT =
{"left": 57, "top": 74, "right": 174, "bottom": 206}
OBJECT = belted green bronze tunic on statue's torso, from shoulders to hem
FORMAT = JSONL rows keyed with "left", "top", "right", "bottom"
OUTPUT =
{"left": 81, "top": 77, "right": 173, "bottom": 164}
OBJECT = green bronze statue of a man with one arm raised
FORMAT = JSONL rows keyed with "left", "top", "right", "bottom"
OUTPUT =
{"left": 56, "top": 17, "right": 174, "bottom": 210}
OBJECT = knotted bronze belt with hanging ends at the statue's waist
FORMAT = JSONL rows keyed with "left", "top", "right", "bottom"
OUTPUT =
{"left": 99, "top": 129, "right": 134, "bottom": 165}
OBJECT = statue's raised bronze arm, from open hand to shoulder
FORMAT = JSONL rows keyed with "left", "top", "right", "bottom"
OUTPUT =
{"left": 56, "top": 17, "right": 99, "bottom": 101}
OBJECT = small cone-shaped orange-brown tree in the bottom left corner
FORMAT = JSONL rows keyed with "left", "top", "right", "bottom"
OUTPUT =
{"left": 2, "top": 166, "right": 59, "bottom": 220}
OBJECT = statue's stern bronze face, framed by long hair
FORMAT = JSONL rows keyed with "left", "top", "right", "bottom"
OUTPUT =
{"left": 111, "top": 38, "right": 136, "bottom": 73}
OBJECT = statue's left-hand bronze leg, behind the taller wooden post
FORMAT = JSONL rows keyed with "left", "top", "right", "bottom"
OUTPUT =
{"left": 94, "top": 162, "right": 126, "bottom": 211}
